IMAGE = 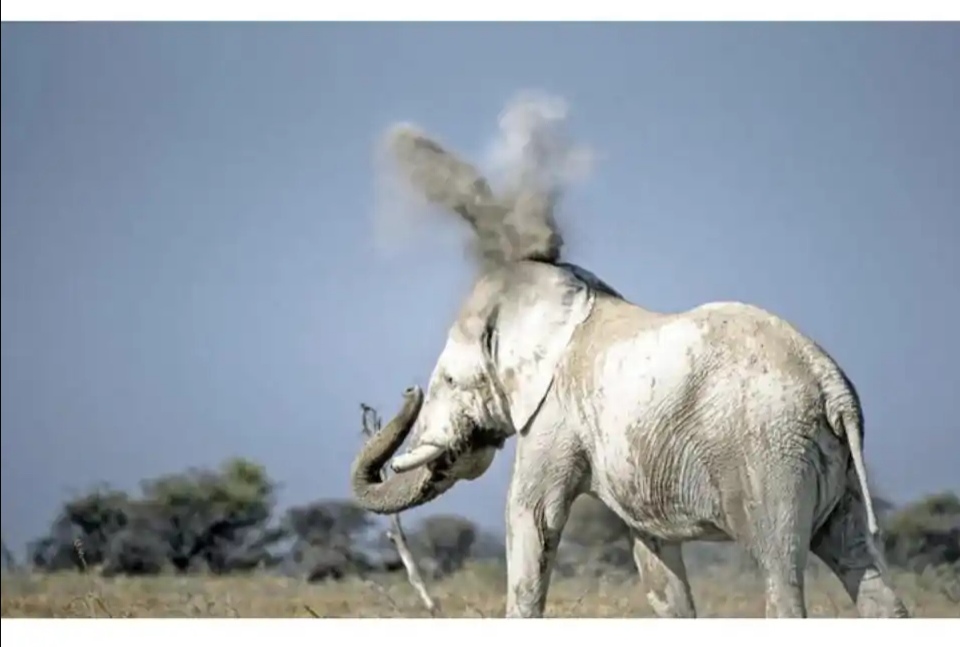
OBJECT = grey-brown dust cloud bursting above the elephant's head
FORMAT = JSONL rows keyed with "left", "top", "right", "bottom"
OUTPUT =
{"left": 374, "top": 92, "right": 595, "bottom": 267}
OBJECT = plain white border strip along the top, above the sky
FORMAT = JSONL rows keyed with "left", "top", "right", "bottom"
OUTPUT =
{"left": 0, "top": 0, "right": 960, "bottom": 21}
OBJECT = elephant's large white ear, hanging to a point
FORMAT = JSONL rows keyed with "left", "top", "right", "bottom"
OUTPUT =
{"left": 488, "top": 263, "right": 595, "bottom": 433}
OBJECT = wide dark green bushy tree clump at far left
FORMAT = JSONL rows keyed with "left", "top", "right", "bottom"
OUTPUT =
{"left": 30, "top": 459, "right": 283, "bottom": 574}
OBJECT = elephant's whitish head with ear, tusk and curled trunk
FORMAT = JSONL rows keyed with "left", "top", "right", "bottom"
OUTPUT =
{"left": 352, "top": 261, "right": 619, "bottom": 514}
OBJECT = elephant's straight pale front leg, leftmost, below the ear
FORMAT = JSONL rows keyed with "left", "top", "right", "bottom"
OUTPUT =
{"left": 506, "top": 446, "right": 578, "bottom": 618}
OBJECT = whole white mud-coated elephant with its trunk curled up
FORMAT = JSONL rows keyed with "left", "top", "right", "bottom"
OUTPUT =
{"left": 352, "top": 125, "right": 907, "bottom": 617}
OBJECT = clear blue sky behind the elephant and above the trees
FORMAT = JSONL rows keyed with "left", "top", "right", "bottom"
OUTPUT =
{"left": 0, "top": 23, "right": 960, "bottom": 545}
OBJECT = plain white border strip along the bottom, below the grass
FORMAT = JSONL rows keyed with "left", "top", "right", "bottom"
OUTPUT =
{"left": 2, "top": 618, "right": 960, "bottom": 636}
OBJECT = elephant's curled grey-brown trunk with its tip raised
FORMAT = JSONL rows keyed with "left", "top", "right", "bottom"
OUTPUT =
{"left": 350, "top": 387, "right": 440, "bottom": 514}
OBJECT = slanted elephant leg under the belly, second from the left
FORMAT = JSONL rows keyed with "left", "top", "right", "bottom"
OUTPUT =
{"left": 633, "top": 534, "right": 697, "bottom": 618}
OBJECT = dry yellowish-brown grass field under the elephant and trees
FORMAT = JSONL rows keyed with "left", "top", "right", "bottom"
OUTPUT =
{"left": 2, "top": 567, "right": 960, "bottom": 618}
